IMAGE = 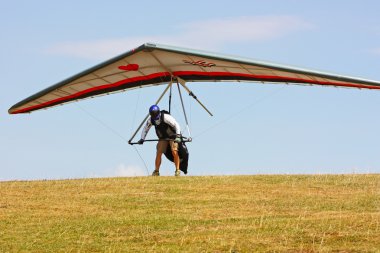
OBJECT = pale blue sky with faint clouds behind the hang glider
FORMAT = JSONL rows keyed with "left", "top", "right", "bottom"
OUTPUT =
{"left": 0, "top": 0, "right": 380, "bottom": 180}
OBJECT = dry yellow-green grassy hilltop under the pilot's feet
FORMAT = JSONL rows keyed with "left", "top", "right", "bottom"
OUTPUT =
{"left": 0, "top": 175, "right": 380, "bottom": 252}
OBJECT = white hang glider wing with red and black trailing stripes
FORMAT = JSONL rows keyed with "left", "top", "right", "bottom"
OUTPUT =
{"left": 8, "top": 43, "right": 380, "bottom": 114}
